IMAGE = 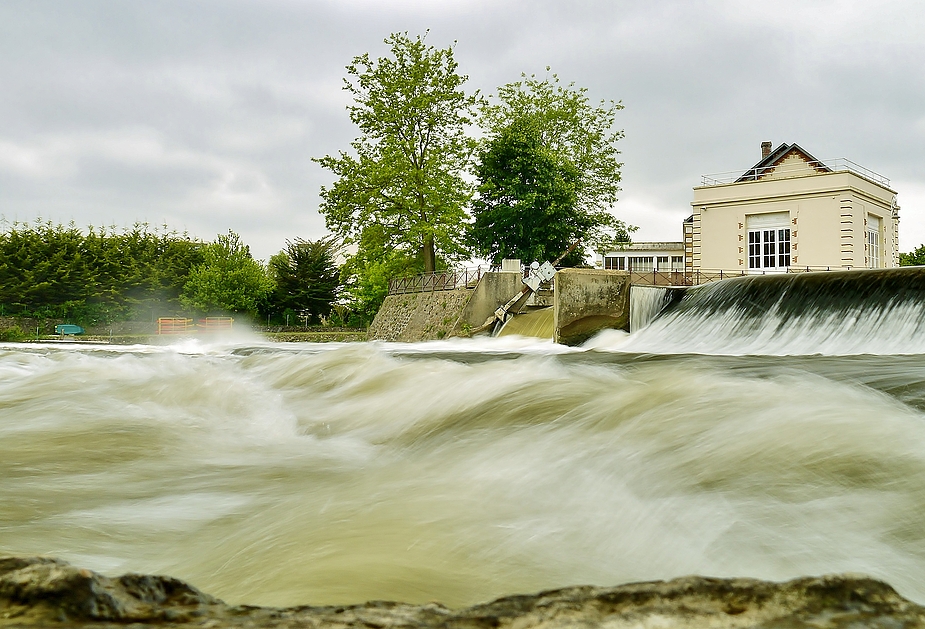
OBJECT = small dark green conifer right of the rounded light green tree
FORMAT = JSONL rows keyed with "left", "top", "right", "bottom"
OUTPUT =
{"left": 269, "top": 237, "right": 340, "bottom": 320}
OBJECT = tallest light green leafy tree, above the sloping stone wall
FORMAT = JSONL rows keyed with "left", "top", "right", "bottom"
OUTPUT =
{"left": 316, "top": 33, "right": 478, "bottom": 271}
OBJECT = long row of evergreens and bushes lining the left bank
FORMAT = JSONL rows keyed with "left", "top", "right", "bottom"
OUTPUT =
{"left": 0, "top": 221, "right": 340, "bottom": 326}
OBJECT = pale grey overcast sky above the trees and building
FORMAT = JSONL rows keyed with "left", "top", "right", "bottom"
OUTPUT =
{"left": 0, "top": 0, "right": 925, "bottom": 259}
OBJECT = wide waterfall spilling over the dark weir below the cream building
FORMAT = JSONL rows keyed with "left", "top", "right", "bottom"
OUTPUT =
{"left": 621, "top": 267, "right": 925, "bottom": 355}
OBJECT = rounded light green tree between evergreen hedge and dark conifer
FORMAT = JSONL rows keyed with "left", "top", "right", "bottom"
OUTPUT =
{"left": 180, "top": 231, "right": 273, "bottom": 315}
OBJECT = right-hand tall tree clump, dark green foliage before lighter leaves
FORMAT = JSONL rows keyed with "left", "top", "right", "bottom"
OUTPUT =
{"left": 469, "top": 74, "right": 634, "bottom": 263}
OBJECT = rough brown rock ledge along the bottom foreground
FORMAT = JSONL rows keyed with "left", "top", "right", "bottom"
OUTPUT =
{"left": 0, "top": 557, "right": 925, "bottom": 629}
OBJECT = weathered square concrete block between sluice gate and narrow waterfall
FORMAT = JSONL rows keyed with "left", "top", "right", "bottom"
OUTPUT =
{"left": 553, "top": 269, "right": 630, "bottom": 345}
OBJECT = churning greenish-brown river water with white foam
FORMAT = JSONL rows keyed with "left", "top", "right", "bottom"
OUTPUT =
{"left": 0, "top": 276, "right": 925, "bottom": 605}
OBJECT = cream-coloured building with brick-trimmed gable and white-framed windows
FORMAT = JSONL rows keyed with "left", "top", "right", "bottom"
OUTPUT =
{"left": 684, "top": 142, "right": 899, "bottom": 272}
